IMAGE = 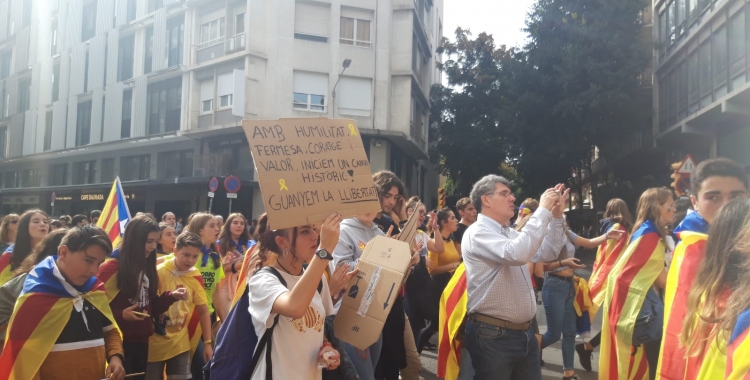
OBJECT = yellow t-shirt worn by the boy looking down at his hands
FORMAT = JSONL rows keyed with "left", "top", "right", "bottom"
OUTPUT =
{"left": 148, "top": 259, "right": 208, "bottom": 362}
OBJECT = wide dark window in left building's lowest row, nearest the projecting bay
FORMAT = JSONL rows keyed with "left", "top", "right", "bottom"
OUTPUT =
{"left": 146, "top": 76, "right": 182, "bottom": 135}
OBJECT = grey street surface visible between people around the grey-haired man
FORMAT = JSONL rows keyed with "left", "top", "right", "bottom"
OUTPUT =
{"left": 422, "top": 249, "right": 602, "bottom": 380}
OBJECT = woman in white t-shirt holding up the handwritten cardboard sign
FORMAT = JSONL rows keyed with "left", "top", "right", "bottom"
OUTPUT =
{"left": 248, "top": 213, "right": 341, "bottom": 380}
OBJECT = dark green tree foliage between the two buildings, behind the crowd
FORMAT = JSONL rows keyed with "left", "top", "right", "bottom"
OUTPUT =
{"left": 431, "top": 0, "right": 651, "bottom": 194}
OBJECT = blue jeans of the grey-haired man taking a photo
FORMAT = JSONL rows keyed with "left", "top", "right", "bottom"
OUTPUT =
{"left": 466, "top": 318, "right": 542, "bottom": 380}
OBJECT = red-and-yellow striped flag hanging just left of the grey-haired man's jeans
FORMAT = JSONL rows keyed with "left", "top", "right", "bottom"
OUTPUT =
{"left": 437, "top": 263, "right": 469, "bottom": 380}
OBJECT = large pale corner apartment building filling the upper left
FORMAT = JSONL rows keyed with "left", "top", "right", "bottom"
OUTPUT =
{"left": 0, "top": 0, "right": 443, "bottom": 216}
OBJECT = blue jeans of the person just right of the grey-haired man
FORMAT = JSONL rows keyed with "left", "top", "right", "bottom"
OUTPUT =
{"left": 542, "top": 276, "right": 576, "bottom": 370}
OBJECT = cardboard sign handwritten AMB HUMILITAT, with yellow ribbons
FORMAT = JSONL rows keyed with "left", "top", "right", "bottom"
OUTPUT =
{"left": 242, "top": 118, "right": 380, "bottom": 229}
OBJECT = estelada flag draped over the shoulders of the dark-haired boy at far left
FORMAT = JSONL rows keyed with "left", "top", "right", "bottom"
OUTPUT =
{"left": 0, "top": 256, "right": 119, "bottom": 380}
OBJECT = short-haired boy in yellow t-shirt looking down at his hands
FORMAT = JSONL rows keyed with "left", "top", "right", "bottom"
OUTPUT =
{"left": 146, "top": 232, "right": 213, "bottom": 380}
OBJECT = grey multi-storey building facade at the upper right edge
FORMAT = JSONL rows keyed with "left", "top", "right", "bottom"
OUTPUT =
{"left": 653, "top": 0, "right": 750, "bottom": 169}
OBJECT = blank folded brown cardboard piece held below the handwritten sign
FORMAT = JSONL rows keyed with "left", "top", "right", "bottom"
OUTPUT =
{"left": 333, "top": 236, "right": 413, "bottom": 350}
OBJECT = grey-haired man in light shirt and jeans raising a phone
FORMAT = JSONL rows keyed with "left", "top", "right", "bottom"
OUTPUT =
{"left": 461, "top": 175, "right": 568, "bottom": 380}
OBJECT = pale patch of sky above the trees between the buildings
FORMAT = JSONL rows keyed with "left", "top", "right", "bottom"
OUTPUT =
{"left": 443, "top": 0, "right": 534, "bottom": 47}
